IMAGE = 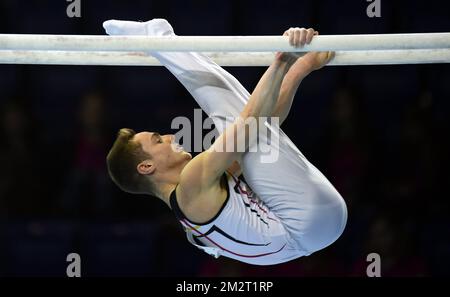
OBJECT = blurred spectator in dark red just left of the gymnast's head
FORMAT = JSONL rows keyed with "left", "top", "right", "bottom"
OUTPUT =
{"left": 61, "top": 92, "right": 113, "bottom": 218}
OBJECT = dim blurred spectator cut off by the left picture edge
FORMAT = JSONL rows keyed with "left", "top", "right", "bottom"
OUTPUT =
{"left": 0, "top": 98, "right": 49, "bottom": 218}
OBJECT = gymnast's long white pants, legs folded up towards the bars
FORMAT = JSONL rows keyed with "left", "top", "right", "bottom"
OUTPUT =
{"left": 104, "top": 19, "right": 347, "bottom": 255}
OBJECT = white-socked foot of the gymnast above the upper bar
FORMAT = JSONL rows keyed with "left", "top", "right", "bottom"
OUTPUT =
{"left": 103, "top": 19, "right": 175, "bottom": 36}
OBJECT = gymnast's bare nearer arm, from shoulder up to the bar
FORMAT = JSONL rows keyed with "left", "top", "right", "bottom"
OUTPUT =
{"left": 179, "top": 54, "right": 289, "bottom": 197}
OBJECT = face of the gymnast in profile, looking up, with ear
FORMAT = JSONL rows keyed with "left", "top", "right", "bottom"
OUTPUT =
{"left": 133, "top": 132, "right": 192, "bottom": 174}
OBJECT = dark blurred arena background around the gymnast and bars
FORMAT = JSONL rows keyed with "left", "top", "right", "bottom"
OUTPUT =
{"left": 0, "top": 0, "right": 450, "bottom": 276}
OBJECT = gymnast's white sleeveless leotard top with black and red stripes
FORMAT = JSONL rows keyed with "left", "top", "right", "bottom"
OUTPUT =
{"left": 170, "top": 173, "right": 301, "bottom": 265}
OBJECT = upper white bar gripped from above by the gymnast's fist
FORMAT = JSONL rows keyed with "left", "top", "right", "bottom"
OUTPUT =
{"left": 0, "top": 33, "right": 450, "bottom": 52}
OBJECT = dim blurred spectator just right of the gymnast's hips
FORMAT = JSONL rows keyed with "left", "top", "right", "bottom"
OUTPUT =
{"left": 315, "top": 87, "right": 377, "bottom": 210}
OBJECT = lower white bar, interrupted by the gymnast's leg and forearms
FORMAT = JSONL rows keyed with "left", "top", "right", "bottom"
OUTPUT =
{"left": 0, "top": 49, "right": 450, "bottom": 66}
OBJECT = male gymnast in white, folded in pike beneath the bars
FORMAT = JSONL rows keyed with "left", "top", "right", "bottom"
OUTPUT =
{"left": 103, "top": 19, "right": 347, "bottom": 265}
